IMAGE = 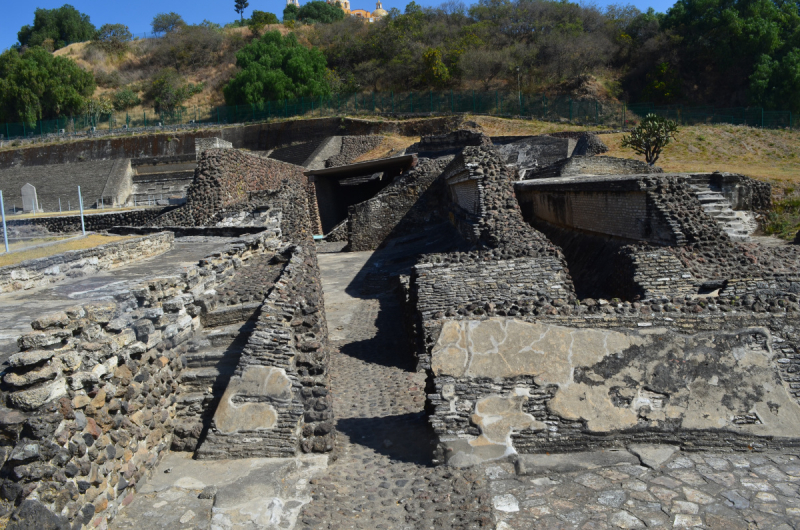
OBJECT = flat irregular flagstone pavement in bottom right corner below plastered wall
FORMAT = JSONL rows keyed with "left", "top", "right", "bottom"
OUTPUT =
{"left": 485, "top": 452, "right": 800, "bottom": 530}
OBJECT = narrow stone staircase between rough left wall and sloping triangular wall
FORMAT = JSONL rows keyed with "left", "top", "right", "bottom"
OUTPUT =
{"left": 172, "top": 321, "right": 254, "bottom": 451}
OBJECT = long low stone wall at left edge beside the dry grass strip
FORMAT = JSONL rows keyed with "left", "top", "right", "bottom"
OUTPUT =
{"left": 0, "top": 232, "right": 174, "bottom": 293}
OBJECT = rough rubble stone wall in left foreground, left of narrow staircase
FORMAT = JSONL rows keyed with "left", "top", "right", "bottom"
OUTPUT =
{"left": 0, "top": 232, "right": 280, "bottom": 528}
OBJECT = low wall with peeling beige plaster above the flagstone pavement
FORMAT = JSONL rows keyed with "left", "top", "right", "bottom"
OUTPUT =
{"left": 431, "top": 318, "right": 800, "bottom": 465}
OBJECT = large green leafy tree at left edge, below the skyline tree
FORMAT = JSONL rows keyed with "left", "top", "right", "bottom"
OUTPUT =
{"left": 0, "top": 47, "right": 96, "bottom": 123}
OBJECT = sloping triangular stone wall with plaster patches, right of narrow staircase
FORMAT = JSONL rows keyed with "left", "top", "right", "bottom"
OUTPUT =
{"left": 197, "top": 243, "right": 334, "bottom": 458}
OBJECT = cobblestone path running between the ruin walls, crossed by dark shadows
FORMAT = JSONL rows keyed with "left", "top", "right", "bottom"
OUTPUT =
{"left": 297, "top": 252, "right": 494, "bottom": 529}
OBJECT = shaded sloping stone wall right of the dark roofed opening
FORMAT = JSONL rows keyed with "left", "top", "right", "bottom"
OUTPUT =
{"left": 346, "top": 157, "right": 452, "bottom": 251}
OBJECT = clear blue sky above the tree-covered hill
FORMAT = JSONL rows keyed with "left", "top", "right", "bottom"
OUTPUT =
{"left": 0, "top": 0, "right": 674, "bottom": 50}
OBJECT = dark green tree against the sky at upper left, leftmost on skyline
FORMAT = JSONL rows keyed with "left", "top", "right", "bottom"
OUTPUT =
{"left": 17, "top": 4, "right": 96, "bottom": 50}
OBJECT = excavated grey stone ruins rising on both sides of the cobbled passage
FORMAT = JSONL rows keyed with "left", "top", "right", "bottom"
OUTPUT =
{"left": 0, "top": 121, "right": 800, "bottom": 527}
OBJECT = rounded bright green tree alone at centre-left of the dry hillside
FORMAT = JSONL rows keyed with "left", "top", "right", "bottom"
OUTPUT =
{"left": 223, "top": 31, "right": 330, "bottom": 105}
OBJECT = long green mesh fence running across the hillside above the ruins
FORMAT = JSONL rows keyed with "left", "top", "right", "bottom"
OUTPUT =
{"left": 0, "top": 91, "right": 794, "bottom": 138}
